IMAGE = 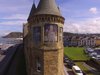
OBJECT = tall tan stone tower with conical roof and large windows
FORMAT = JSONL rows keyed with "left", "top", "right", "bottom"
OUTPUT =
{"left": 23, "top": 0, "right": 64, "bottom": 75}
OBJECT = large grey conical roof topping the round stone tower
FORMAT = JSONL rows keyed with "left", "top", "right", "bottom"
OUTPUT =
{"left": 35, "top": 0, "right": 61, "bottom": 16}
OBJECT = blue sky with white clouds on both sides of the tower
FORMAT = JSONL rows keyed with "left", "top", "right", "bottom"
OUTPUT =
{"left": 0, "top": 0, "right": 100, "bottom": 36}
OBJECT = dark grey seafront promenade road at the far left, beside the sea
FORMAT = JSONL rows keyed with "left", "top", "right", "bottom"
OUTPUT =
{"left": 0, "top": 45, "right": 18, "bottom": 75}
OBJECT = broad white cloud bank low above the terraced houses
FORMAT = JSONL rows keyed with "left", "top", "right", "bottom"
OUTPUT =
{"left": 64, "top": 17, "right": 100, "bottom": 33}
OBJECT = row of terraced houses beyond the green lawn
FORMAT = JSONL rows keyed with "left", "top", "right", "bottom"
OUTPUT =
{"left": 63, "top": 33, "right": 100, "bottom": 47}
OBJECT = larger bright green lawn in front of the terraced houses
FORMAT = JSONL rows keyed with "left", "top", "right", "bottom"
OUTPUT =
{"left": 64, "top": 47, "right": 89, "bottom": 60}
